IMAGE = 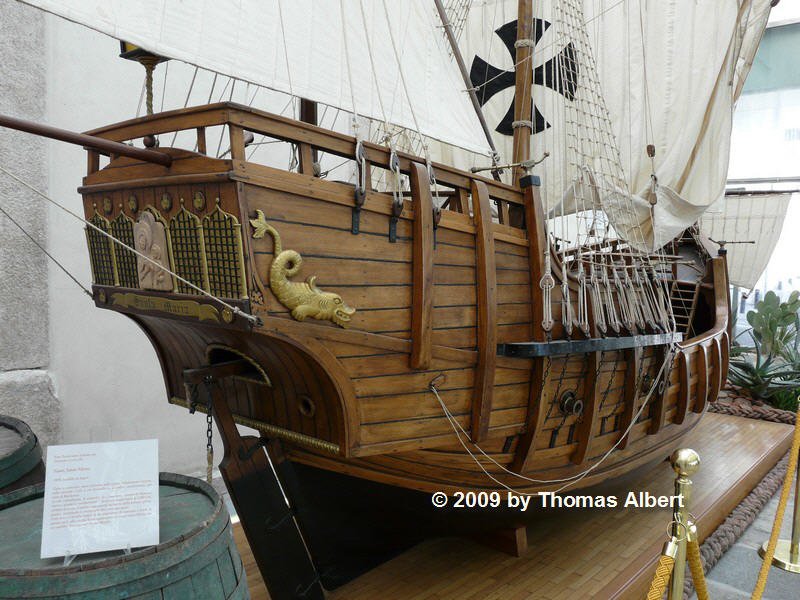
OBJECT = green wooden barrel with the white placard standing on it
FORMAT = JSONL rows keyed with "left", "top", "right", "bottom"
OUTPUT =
{"left": 0, "top": 473, "right": 250, "bottom": 600}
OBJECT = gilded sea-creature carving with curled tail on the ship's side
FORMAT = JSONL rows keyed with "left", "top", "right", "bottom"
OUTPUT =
{"left": 250, "top": 210, "right": 356, "bottom": 327}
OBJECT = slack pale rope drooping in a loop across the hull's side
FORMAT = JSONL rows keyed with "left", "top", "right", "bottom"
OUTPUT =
{"left": 429, "top": 350, "right": 667, "bottom": 496}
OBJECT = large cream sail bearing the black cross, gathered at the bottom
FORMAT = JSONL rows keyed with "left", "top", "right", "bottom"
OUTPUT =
{"left": 460, "top": 0, "right": 770, "bottom": 251}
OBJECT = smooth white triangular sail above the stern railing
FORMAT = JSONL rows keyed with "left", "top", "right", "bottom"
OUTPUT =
{"left": 23, "top": 0, "right": 488, "bottom": 153}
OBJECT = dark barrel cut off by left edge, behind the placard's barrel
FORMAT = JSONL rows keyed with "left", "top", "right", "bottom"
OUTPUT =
{"left": 0, "top": 415, "right": 44, "bottom": 494}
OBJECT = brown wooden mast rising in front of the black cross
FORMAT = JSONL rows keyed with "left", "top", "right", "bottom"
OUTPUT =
{"left": 511, "top": 0, "right": 533, "bottom": 185}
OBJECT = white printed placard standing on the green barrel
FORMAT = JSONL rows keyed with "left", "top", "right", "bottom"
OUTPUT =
{"left": 41, "top": 440, "right": 158, "bottom": 558}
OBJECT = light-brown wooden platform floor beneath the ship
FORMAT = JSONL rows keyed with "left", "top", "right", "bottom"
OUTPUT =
{"left": 235, "top": 414, "right": 792, "bottom": 600}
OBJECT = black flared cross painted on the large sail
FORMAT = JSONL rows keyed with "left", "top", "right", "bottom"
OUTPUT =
{"left": 469, "top": 18, "right": 578, "bottom": 136}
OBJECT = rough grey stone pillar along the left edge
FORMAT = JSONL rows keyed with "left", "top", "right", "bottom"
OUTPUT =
{"left": 0, "top": 0, "right": 61, "bottom": 444}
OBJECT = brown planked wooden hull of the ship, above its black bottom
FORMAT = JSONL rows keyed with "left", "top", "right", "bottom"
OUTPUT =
{"left": 81, "top": 104, "right": 728, "bottom": 494}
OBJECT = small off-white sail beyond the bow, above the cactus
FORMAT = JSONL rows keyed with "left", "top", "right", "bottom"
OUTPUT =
{"left": 700, "top": 192, "right": 792, "bottom": 290}
